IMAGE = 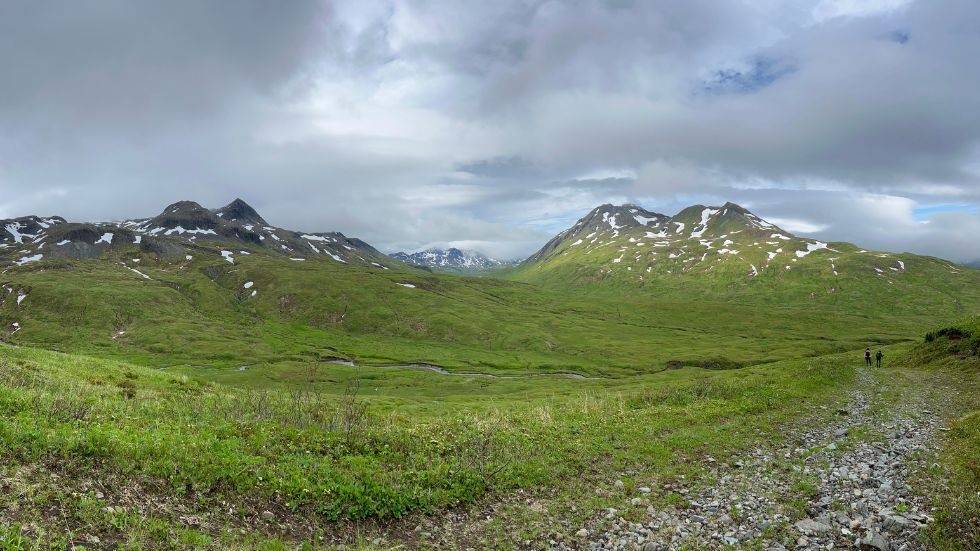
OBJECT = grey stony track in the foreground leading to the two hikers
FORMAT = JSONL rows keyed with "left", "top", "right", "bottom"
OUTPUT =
{"left": 572, "top": 371, "right": 941, "bottom": 551}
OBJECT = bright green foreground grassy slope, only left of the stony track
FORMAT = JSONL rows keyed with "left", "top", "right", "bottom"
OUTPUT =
{"left": 0, "top": 342, "right": 851, "bottom": 546}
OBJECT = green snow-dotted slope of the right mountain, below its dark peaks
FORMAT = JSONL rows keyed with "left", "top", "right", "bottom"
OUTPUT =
{"left": 507, "top": 213, "right": 980, "bottom": 322}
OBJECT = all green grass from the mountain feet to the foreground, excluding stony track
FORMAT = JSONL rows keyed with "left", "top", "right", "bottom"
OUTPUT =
{"left": 0, "top": 243, "right": 980, "bottom": 549}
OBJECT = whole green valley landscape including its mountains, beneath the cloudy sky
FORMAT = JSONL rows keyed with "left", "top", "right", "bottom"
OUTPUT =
{"left": 0, "top": 200, "right": 980, "bottom": 551}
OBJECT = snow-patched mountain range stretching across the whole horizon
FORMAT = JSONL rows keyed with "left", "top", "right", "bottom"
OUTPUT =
{"left": 0, "top": 199, "right": 972, "bottom": 294}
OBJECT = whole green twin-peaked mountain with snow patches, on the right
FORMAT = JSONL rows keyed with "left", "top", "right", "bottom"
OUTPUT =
{"left": 508, "top": 203, "right": 980, "bottom": 308}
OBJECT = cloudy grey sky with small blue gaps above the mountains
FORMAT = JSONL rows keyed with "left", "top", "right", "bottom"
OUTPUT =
{"left": 0, "top": 0, "right": 980, "bottom": 261}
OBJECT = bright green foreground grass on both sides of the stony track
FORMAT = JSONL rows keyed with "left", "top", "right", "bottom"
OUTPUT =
{"left": 0, "top": 325, "right": 980, "bottom": 549}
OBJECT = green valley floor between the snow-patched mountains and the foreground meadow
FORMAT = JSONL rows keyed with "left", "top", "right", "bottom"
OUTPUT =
{"left": 0, "top": 242, "right": 973, "bottom": 382}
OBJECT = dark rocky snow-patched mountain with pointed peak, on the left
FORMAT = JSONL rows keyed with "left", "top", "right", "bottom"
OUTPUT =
{"left": 0, "top": 199, "right": 389, "bottom": 269}
